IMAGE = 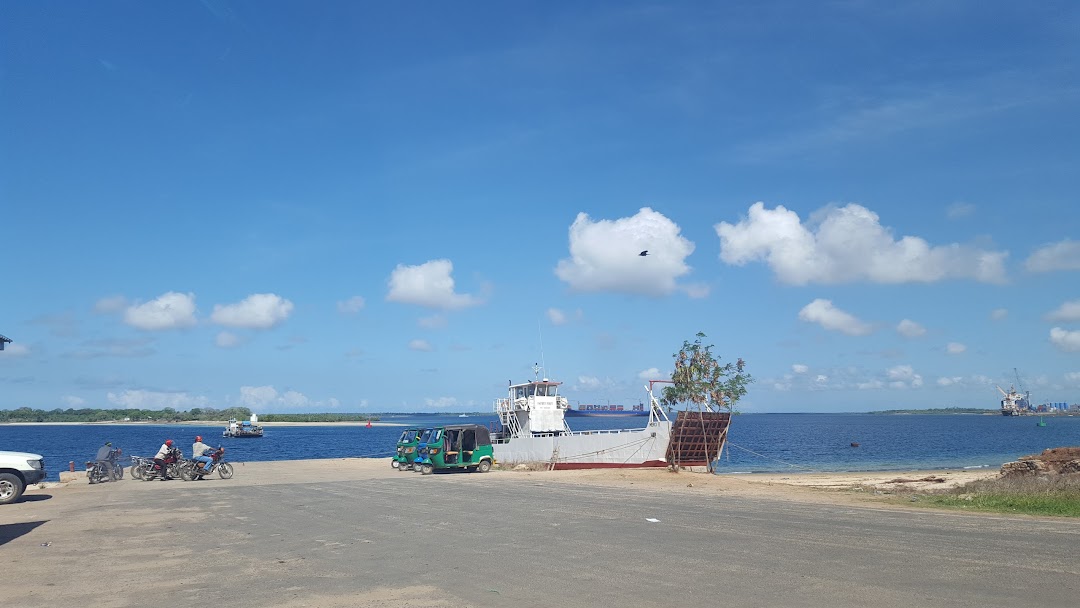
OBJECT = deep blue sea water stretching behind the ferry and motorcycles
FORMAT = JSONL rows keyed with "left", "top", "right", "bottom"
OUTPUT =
{"left": 0, "top": 414, "right": 1080, "bottom": 479}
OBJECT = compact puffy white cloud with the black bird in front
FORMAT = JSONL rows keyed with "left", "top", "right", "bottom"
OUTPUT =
{"left": 555, "top": 207, "right": 702, "bottom": 297}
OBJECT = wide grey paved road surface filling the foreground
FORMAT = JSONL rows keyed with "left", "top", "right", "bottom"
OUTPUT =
{"left": 0, "top": 461, "right": 1080, "bottom": 608}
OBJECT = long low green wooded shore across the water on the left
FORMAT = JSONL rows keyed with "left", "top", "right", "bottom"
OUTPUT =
{"left": 0, "top": 407, "right": 379, "bottom": 423}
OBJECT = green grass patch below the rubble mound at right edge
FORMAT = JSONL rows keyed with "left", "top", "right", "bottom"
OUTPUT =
{"left": 918, "top": 475, "right": 1080, "bottom": 517}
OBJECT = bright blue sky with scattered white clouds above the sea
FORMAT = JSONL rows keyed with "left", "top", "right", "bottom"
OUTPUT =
{"left": 0, "top": 0, "right": 1080, "bottom": 413}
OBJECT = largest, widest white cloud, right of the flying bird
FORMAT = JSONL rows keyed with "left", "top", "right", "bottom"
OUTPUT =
{"left": 715, "top": 203, "right": 1009, "bottom": 285}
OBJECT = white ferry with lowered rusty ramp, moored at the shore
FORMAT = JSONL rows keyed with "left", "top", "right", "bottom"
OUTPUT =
{"left": 491, "top": 367, "right": 730, "bottom": 470}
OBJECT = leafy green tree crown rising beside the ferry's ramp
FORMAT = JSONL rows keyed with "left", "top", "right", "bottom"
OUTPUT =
{"left": 660, "top": 332, "right": 754, "bottom": 413}
